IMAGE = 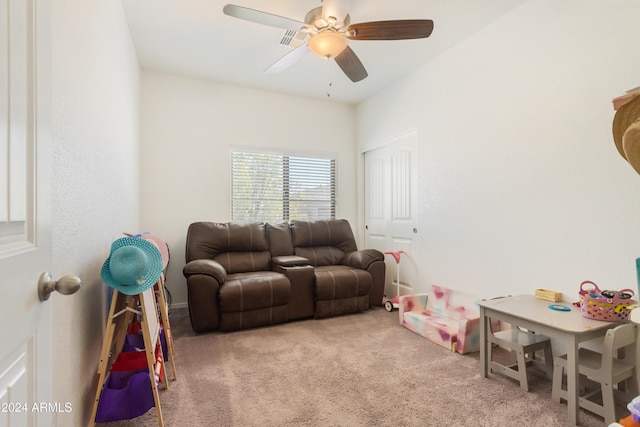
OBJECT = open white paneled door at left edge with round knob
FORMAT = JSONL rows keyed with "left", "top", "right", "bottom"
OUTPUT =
{"left": 0, "top": 0, "right": 57, "bottom": 427}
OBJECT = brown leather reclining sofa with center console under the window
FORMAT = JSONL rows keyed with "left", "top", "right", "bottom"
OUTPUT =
{"left": 183, "top": 220, "right": 385, "bottom": 332}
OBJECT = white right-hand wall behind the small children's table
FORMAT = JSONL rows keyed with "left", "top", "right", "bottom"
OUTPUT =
{"left": 356, "top": 0, "right": 640, "bottom": 300}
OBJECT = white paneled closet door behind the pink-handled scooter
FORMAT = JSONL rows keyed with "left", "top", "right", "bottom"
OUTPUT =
{"left": 364, "top": 131, "right": 419, "bottom": 297}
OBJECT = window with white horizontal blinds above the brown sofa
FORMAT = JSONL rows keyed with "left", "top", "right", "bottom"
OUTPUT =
{"left": 231, "top": 150, "right": 336, "bottom": 222}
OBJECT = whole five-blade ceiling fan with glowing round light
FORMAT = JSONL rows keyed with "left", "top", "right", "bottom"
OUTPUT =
{"left": 223, "top": 0, "right": 433, "bottom": 82}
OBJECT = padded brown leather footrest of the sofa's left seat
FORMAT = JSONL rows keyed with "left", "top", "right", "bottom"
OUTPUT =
{"left": 219, "top": 271, "right": 291, "bottom": 313}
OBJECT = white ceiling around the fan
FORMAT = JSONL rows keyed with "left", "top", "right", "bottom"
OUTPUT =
{"left": 122, "top": 0, "right": 525, "bottom": 104}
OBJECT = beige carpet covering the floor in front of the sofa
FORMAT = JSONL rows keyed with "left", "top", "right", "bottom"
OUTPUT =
{"left": 100, "top": 308, "right": 628, "bottom": 427}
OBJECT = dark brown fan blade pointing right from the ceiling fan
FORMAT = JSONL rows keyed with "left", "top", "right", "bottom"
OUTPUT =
{"left": 346, "top": 19, "right": 433, "bottom": 40}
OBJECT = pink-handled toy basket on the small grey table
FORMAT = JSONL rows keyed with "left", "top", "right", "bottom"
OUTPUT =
{"left": 579, "top": 280, "right": 637, "bottom": 322}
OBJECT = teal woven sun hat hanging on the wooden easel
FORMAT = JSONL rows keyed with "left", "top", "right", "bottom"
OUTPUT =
{"left": 100, "top": 237, "right": 162, "bottom": 295}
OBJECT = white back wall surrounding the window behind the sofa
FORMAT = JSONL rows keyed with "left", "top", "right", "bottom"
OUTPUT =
{"left": 140, "top": 71, "right": 357, "bottom": 305}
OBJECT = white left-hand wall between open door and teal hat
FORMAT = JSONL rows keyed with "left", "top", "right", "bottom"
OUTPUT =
{"left": 50, "top": 0, "right": 139, "bottom": 426}
